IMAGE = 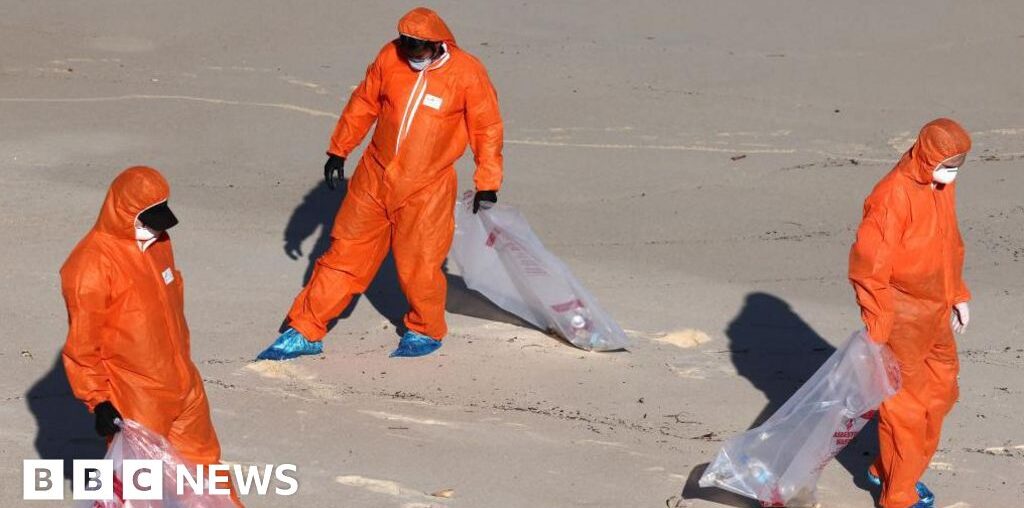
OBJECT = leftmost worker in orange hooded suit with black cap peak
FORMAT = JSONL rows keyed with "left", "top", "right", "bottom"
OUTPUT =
{"left": 60, "top": 166, "right": 241, "bottom": 506}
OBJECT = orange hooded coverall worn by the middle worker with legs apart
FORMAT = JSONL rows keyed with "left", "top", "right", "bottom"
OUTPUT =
{"left": 288, "top": 7, "right": 503, "bottom": 341}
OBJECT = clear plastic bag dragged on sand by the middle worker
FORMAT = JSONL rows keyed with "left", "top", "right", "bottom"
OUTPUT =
{"left": 452, "top": 193, "right": 629, "bottom": 351}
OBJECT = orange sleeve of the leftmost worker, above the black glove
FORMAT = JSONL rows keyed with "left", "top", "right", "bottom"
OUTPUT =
{"left": 61, "top": 252, "right": 111, "bottom": 411}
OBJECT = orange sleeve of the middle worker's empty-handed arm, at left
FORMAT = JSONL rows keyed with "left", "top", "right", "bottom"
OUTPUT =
{"left": 327, "top": 50, "right": 384, "bottom": 158}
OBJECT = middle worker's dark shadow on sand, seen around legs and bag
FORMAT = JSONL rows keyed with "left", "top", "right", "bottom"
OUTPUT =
{"left": 282, "top": 179, "right": 536, "bottom": 335}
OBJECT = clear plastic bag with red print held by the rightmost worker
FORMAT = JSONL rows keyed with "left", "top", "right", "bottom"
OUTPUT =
{"left": 700, "top": 331, "right": 900, "bottom": 507}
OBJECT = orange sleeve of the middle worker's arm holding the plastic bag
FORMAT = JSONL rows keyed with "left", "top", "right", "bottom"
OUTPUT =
{"left": 466, "top": 67, "right": 505, "bottom": 191}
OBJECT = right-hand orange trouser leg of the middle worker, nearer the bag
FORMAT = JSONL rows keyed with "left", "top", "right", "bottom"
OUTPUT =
{"left": 392, "top": 171, "right": 458, "bottom": 340}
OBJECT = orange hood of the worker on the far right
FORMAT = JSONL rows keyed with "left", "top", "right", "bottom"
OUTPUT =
{"left": 899, "top": 118, "right": 971, "bottom": 183}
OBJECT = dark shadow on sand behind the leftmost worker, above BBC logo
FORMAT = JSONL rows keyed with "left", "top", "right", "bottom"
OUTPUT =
{"left": 25, "top": 353, "right": 106, "bottom": 481}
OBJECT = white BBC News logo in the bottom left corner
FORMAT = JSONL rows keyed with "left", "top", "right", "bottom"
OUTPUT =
{"left": 22, "top": 459, "right": 299, "bottom": 501}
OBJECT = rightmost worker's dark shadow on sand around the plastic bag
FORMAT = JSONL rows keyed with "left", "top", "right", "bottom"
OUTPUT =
{"left": 683, "top": 293, "right": 878, "bottom": 506}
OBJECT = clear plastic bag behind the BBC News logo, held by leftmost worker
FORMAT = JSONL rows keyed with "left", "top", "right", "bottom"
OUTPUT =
{"left": 82, "top": 419, "right": 234, "bottom": 508}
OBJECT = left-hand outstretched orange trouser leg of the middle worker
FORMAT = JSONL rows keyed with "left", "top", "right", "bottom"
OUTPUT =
{"left": 288, "top": 187, "right": 391, "bottom": 341}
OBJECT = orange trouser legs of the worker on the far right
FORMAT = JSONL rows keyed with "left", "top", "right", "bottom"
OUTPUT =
{"left": 874, "top": 330, "right": 958, "bottom": 508}
